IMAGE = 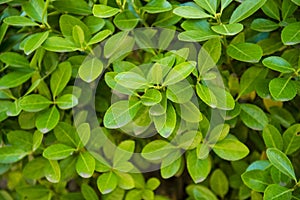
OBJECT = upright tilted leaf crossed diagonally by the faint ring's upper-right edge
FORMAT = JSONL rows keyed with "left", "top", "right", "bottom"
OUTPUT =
{"left": 198, "top": 38, "right": 222, "bottom": 75}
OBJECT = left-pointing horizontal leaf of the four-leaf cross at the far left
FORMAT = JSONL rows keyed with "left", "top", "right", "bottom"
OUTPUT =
{"left": 19, "top": 94, "right": 52, "bottom": 112}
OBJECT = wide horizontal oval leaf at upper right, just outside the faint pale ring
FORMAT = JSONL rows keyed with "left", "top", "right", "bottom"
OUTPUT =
{"left": 226, "top": 42, "right": 263, "bottom": 63}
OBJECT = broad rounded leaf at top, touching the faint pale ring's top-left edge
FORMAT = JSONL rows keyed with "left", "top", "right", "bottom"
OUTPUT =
{"left": 114, "top": 10, "right": 140, "bottom": 30}
